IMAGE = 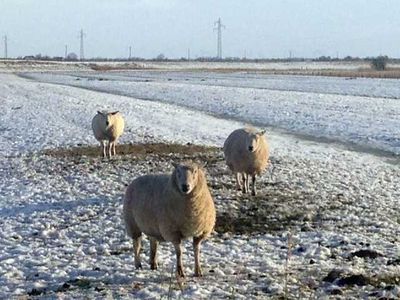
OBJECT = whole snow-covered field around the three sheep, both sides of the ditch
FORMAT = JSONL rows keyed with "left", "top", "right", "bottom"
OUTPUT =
{"left": 0, "top": 71, "right": 400, "bottom": 299}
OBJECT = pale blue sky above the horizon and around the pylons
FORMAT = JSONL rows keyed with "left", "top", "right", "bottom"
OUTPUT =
{"left": 0, "top": 0, "right": 400, "bottom": 58}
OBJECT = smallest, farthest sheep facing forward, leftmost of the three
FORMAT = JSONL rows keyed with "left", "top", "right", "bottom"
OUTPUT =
{"left": 92, "top": 111, "right": 125, "bottom": 158}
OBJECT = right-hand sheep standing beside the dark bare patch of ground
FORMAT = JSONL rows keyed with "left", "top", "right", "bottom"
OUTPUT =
{"left": 223, "top": 127, "right": 269, "bottom": 196}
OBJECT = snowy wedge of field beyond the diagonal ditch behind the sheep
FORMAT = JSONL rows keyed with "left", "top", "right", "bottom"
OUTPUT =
{"left": 27, "top": 71, "right": 400, "bottom": 154}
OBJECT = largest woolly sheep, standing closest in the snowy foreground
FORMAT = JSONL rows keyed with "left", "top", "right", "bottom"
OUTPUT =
{"left": 123, "top": 163, "right": 216, "bottom": 277}
